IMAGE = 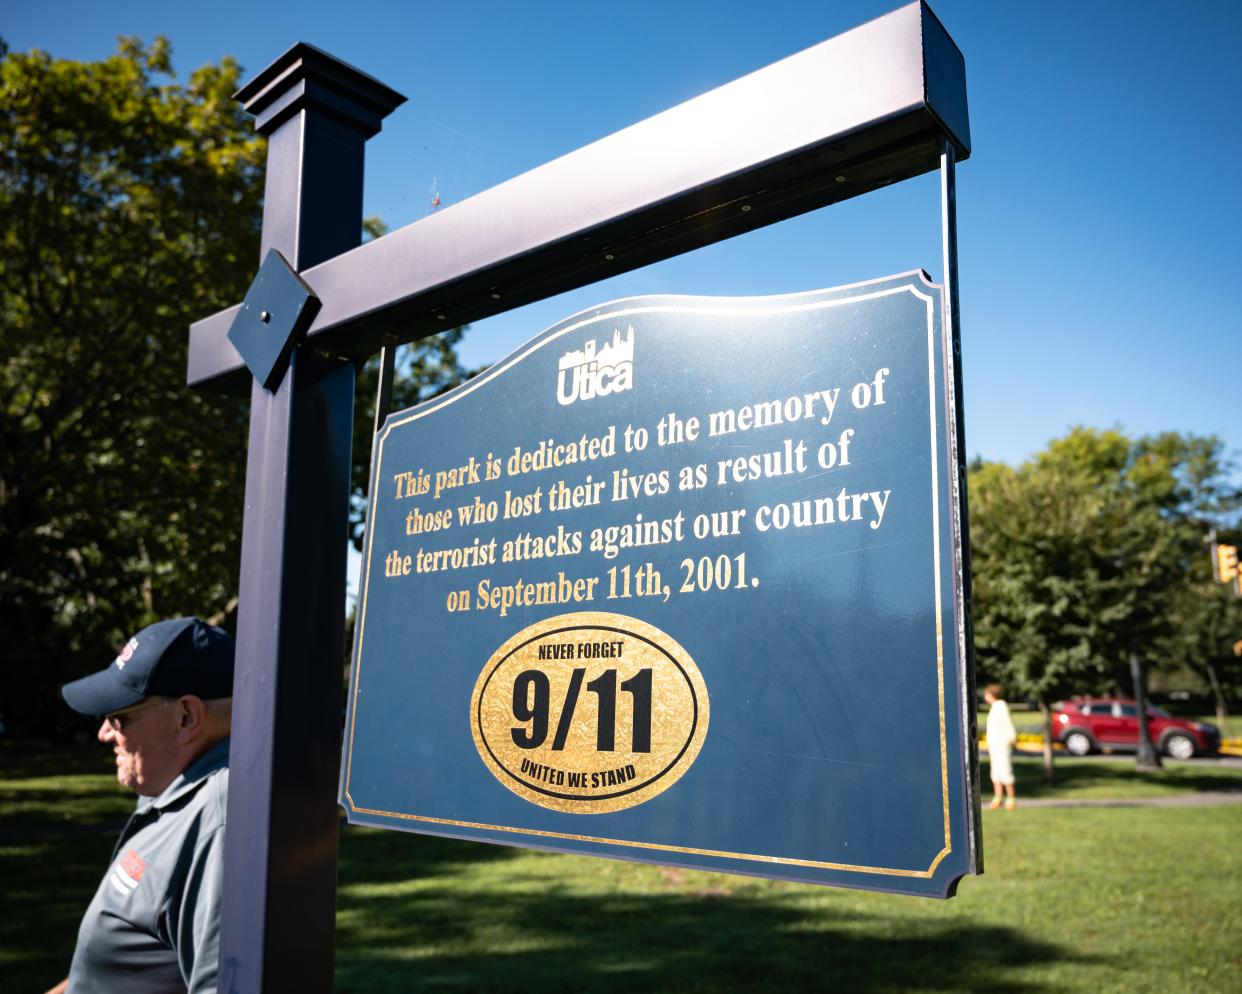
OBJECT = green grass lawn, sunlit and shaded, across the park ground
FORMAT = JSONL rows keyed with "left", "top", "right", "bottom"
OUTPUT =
{"left": 0, "top": 749, "right": 1242, "bottom": 994}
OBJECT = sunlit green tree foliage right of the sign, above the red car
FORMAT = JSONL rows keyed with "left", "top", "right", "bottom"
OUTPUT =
{"left": 970, "top": 429, "right": 1242, "bottom": 703}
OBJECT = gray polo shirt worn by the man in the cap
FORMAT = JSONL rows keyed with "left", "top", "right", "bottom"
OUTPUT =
{"left": 68, "top": 739, "right": 229, "bottom": 994}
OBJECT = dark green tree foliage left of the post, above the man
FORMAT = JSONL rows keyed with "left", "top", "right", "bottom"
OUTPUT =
{"left": 0, "top": 39, "right": 265, "bottom": 728}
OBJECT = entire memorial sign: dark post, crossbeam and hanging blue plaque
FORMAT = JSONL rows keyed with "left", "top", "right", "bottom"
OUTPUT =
{"left": 186, "top": 1, "right": 982, "bottom": 992}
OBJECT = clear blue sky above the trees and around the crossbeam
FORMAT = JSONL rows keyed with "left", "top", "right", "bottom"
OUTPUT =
{"left": 9, "top": 0, "right": 1242, "bottom": 462}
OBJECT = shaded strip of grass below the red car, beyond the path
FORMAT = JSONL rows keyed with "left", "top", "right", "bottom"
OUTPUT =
{"left": 1008, "top": 755, "right": 1242, "bottom": 798}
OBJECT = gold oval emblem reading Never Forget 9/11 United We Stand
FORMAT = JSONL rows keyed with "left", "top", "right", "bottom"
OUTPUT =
{"left": 471, "top": 611, "right": 709, "bottom": 814}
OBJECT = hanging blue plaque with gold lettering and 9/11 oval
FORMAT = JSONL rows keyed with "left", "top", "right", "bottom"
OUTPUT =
{"left": 340, "top": 272, "right": 977, "bottom": 897}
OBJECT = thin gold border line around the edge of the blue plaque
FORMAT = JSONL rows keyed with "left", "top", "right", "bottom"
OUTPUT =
{"left": 344, "top": 270, "right": 953, "bottom": 878}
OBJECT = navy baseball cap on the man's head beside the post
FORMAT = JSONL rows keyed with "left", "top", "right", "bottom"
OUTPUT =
{"left": 61, "top": 618, "right": 233, "bottom": 714}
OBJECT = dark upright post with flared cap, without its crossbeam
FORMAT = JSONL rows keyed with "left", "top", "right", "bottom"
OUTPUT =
{"left": 220, "top": 45, "right": 404, "bottom": 994}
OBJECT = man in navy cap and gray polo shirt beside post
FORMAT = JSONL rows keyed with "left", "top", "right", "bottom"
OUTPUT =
{"left": 48, "top": 618, "right": 233, "bottom": 994}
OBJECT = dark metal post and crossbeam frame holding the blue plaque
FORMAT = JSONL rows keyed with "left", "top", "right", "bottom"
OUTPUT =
{"left": 186, "top": 2, "right": 981, "bottom": 992}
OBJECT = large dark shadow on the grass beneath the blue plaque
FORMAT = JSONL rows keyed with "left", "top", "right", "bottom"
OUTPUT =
{"left": 337, "top": 834, "right": 1086, "bottom": 994}
